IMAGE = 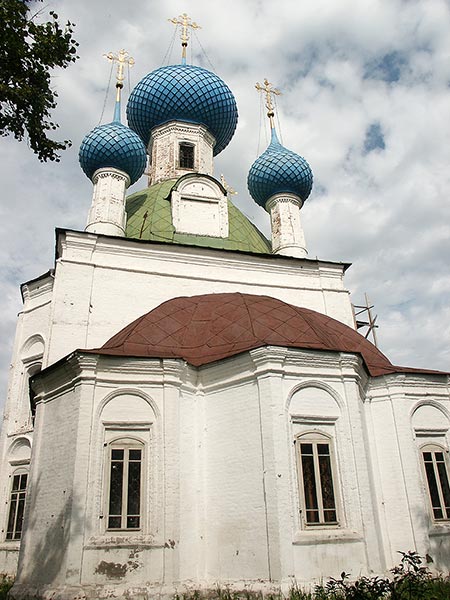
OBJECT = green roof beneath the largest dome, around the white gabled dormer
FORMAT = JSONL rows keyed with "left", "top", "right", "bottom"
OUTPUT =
{"left": 125, "top": 179, "right": 272, "bottom": 254}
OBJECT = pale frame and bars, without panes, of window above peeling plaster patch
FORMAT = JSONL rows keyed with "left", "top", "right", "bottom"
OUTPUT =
{"left": 103, "top": 436, "right": 147, "bottom": 533}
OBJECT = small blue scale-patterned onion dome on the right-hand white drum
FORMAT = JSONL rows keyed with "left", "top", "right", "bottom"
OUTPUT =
{"left": 247, "top": 129, "right": 313, "bottom": 208}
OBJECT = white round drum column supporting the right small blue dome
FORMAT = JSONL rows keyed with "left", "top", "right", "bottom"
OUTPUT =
{"left": 266, "top": 194, "right": 308, "bottom": 258}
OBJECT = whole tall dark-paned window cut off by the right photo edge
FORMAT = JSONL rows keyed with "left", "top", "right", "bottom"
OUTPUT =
{"left": 421, "top": 444, "right": 450, "bottom": 521}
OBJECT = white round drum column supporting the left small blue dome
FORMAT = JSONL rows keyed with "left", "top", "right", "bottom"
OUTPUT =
{"left": 86, "top": 168, "right": 130, "bottom": 237}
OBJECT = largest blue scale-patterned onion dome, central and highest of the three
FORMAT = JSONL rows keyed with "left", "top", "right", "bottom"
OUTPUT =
{"left": 127, "top": 65, "right": 237, "bottom": 155}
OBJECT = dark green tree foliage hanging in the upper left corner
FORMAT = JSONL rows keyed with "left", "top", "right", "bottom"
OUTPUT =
{"left": 0, "top": 0, "right": 78, "bottom": 161}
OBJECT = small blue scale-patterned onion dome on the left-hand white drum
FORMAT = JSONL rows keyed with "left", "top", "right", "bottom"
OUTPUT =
{"left": 78, "top": 121, "right": 147, "bottom": 184}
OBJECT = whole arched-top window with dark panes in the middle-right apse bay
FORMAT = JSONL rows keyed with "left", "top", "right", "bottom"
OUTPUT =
{"left": 295, "top": 432, "right": 338, "bottom": 526}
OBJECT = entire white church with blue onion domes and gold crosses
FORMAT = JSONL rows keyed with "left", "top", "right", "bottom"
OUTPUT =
{"left": 0, "top": 15, "right": 450, "bottom": 600}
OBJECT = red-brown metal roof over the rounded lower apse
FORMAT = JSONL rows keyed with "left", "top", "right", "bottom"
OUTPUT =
{"left": 92, "top": 293, "right": 446, "bottom": 376}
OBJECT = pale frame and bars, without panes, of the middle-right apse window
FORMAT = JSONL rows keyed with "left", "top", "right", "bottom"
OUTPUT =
{"left": 294, "top": 431, "right": 341, "bottom": 529}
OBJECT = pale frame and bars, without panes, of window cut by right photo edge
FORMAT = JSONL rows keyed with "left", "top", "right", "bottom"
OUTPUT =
{"left": 419, "top": 442, "right": 450, "bottom": 523}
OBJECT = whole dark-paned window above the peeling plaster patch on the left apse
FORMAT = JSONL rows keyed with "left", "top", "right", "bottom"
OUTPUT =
{"left": 108, "top": 446, "right": 142, "bottom": 529}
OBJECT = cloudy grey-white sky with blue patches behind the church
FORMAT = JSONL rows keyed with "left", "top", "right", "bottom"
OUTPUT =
{"left": 0, "top": 0, "right": 450, "bottom": 403}
